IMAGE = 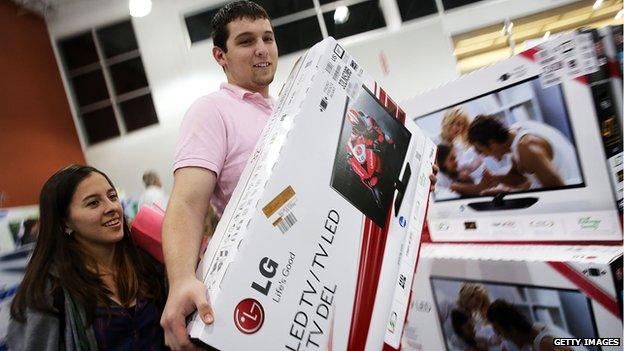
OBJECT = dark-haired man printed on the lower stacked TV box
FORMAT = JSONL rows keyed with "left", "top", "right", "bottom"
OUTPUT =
{"left": 487, "top": 299, "right": 587, "bottom": 351}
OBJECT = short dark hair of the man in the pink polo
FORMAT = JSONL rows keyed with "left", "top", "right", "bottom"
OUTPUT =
{"left": 212, "top": 0, "right": 269, "bottom": 52}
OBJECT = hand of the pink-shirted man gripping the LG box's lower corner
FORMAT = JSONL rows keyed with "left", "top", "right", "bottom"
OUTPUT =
{"left": 160, "top": 277, "right": 214, "bottom": 350}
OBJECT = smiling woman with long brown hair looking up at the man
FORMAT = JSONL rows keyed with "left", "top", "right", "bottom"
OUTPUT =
{"left": 7, "top": 165, "right": 165, "bottom": 350}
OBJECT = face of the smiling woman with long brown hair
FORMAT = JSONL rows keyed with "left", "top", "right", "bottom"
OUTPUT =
{"left": 67, "top": 172, "right": 124, "bottom": 246}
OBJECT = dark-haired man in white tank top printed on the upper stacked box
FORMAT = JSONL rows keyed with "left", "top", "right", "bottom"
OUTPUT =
{"left": 468, "top": 115, "right": 582, "bottom": 192}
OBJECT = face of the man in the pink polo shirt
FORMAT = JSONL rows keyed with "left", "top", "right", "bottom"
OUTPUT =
{"left": 213, "top": 18, "right": 277, "bottom": 96}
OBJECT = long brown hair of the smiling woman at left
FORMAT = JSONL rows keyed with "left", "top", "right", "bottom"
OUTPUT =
{"left": 11, "top": 165, "right": 164, "bottom": 323}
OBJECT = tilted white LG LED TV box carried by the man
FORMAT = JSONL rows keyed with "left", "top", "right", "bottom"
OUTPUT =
{"left": 188, "top": 38, "right": 435, "bottom": 350}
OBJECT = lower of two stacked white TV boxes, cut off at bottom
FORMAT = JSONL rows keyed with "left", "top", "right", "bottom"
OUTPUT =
{"left": 402, "top": 244, "right": 622, "bottom": 351}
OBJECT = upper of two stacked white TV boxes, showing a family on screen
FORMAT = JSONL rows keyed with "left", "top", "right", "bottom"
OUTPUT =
{"left": 404, "top": 33, "right": 622, "bottom": 242}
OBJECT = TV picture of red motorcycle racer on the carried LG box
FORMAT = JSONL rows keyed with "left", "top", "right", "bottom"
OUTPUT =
{"left": 331, "top": 86, "right": 411, "bottom": 227}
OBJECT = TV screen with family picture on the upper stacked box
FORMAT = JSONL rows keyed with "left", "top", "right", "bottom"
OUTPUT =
{"left": 415, "top": 77, "right": 585, "bottom": 201}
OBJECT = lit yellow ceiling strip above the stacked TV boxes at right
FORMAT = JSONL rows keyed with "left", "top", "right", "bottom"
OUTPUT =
{"left": 453, "top": 0, "right": 622, "bottom": 73}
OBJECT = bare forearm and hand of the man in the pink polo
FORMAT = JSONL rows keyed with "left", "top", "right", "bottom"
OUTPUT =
{"left": 160, "top": 167, "right": 217, "bottom": 350}
